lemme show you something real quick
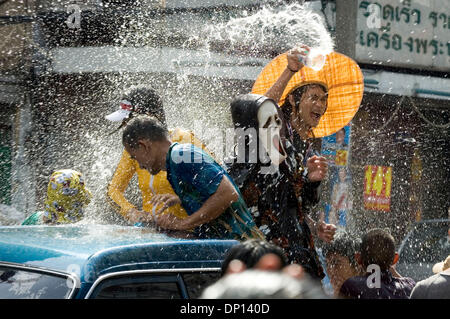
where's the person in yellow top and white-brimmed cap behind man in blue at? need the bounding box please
[106,87,208,223]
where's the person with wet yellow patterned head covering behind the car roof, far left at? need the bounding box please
[22,169,92,225]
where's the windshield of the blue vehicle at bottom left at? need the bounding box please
[0,267,73,299]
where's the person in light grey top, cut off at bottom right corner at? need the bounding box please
[410,255,450,299]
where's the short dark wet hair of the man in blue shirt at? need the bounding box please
[122,115,169,149]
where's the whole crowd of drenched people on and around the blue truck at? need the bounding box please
[18,48,450,298]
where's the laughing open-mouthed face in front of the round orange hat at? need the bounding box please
[289,85,328,128]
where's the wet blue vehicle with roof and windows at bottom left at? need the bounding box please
[0,225,238,299]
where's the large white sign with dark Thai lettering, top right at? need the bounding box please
[356,0,450,71]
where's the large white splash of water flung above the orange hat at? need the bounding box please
[205,3,334,57]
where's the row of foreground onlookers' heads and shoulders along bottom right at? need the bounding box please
[201,238,450,299]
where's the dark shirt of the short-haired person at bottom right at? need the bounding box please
[340,270,416,299]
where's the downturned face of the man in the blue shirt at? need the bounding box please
[125,140,166,175]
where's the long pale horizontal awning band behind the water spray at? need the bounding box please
[51,46,269,80]
